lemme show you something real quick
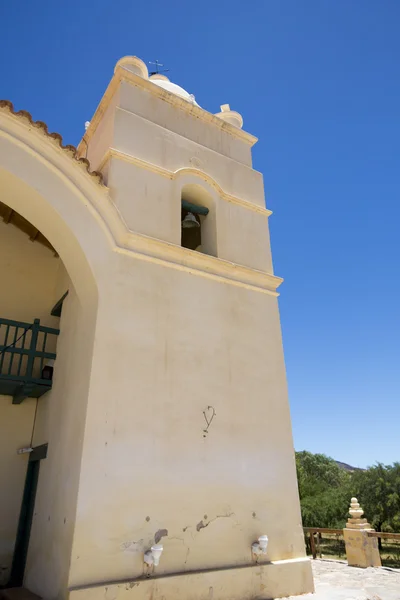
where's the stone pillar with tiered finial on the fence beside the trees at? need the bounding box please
[343,498,382,568]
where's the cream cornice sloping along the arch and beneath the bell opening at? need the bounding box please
[0,102,283,296]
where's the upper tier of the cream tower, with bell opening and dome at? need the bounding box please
[79,57,279,272]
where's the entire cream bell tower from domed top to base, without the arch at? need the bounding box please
[71,56,313,600]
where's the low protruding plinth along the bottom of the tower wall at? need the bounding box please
[69,558,314,600]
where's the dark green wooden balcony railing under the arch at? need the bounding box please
[0,318,60,404]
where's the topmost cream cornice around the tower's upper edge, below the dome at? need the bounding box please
[78,66,258,154]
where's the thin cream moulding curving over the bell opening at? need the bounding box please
[98,148,272,217]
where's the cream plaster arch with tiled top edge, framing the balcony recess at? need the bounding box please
[0,111,113,597]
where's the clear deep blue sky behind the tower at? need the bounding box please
[0,0,400,466]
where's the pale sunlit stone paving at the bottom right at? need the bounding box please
[282,560,400,600]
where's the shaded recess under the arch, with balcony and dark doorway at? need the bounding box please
[0,199,61,586]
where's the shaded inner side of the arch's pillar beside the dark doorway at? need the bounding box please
[25,283,96,600]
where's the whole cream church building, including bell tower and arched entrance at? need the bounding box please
[0,56,313,600]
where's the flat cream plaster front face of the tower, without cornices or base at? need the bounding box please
[69,67,304,586]
